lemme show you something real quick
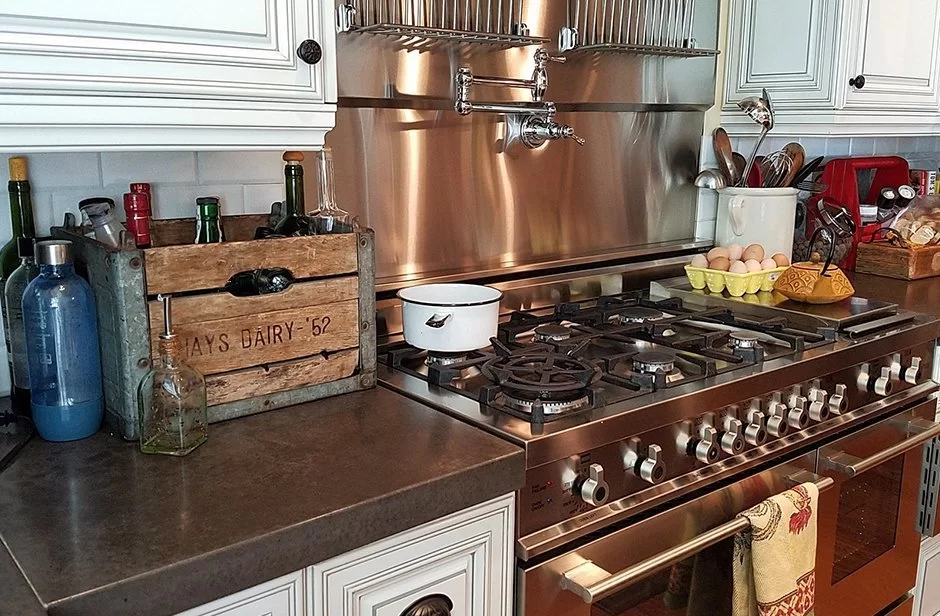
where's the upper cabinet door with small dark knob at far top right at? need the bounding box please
[843,0,940,111]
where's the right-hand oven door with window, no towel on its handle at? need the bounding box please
[816,398,940,616]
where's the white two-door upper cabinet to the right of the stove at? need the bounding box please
[722,0,940,136]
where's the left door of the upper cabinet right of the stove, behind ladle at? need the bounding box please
[724,0,838,113]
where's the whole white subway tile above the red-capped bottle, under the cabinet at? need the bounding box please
[101,152,196,185]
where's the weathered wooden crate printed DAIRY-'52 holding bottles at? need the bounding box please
[53,215,375,439]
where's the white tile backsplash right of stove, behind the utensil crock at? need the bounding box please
[695,133,940,239]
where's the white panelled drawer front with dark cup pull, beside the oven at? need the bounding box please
[307,495,514,616]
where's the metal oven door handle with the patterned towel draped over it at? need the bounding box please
[561,473,835,603]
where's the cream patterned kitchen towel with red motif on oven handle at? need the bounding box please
[733,483,819,616]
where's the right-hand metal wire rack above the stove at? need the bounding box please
[558,0,718,57]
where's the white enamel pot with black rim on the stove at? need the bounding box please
[398,284,503,353]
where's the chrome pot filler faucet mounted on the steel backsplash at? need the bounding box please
[454,48,585,149]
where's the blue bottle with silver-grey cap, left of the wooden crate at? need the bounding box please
[23,240,104,441]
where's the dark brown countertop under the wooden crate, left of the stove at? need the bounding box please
[0,388,525,616]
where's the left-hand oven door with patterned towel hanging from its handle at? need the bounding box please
[517,454,832,616]
